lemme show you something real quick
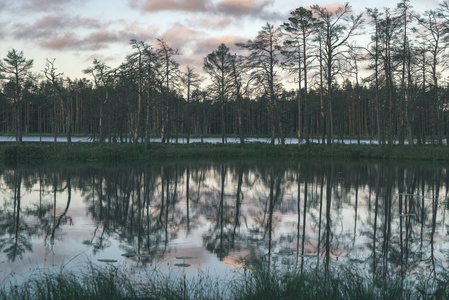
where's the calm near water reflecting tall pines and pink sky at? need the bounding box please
[0,161,449,283]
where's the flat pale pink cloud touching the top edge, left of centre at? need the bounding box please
[129,0,210,12]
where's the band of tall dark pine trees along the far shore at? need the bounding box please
[0,0,449,146]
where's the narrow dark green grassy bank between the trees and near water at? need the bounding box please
[0,143,449,163]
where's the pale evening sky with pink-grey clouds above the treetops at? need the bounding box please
[0,0,441,79]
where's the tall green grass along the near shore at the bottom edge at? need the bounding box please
[0,265,449,300]
